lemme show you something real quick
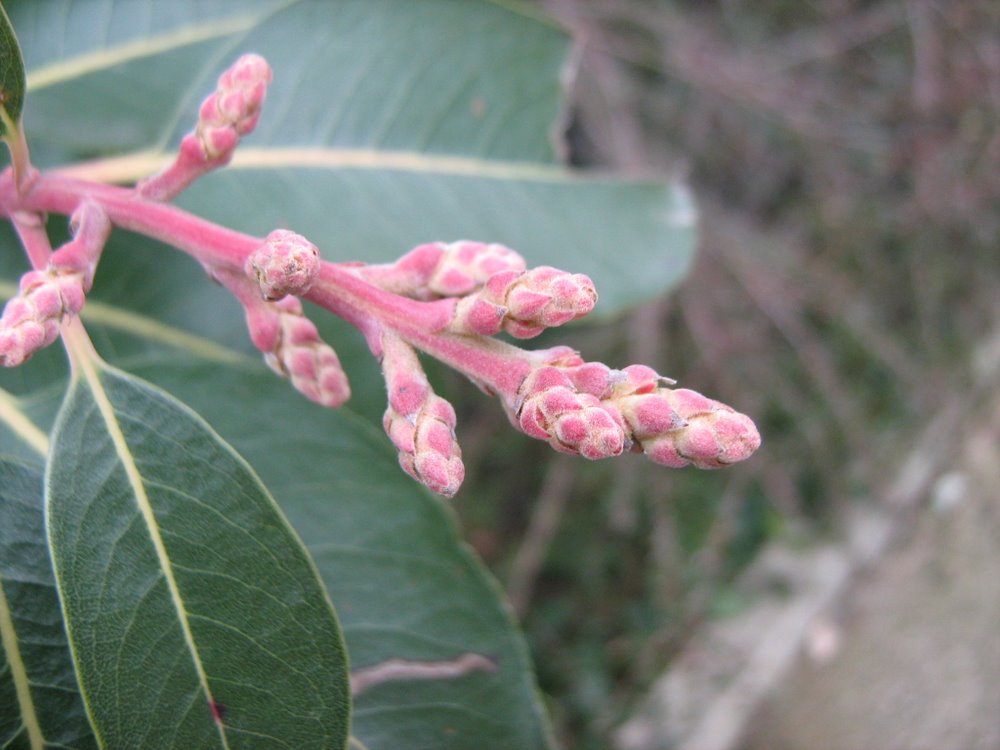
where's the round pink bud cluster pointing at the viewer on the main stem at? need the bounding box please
[246,229,320,300]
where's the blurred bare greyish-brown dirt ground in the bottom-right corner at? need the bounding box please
[744,390,1000,750]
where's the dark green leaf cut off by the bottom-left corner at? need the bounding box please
[0,459,97,750]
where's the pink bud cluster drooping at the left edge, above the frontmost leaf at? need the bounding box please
[0,202,111,367]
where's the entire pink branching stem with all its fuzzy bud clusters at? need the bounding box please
[0,55,760,496]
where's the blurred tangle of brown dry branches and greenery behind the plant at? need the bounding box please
[459,0,1000,748]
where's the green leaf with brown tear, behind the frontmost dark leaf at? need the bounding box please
[130,354,551,750]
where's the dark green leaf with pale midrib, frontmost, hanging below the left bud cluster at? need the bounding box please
[46,354,349,749]
